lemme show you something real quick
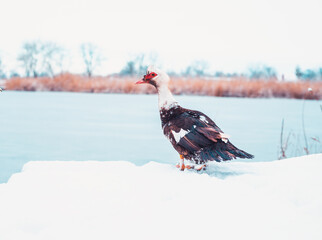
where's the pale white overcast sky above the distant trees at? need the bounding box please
[0,0,322,78]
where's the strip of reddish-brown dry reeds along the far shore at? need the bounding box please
[5,73,322,99]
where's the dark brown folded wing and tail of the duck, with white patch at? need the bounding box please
[163,110,253,163]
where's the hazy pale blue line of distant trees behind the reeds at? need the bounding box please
[0,41,322,81]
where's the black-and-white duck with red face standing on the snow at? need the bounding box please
[136,65,254,171]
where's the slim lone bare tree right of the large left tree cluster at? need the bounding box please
[80,43,103,77]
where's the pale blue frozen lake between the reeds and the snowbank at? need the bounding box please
[0,92,322,183]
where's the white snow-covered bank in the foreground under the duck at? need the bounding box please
[0,154,322,240]
